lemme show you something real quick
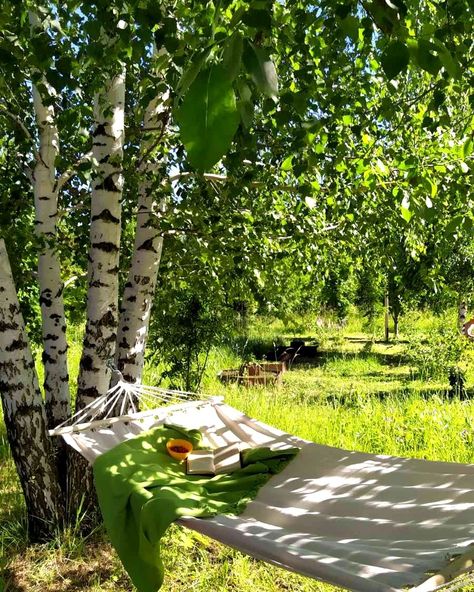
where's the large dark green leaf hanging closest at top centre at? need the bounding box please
[176,66,239,170]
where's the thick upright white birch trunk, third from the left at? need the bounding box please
[77,70,125,406]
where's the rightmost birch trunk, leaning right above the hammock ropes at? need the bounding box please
[116,96,167,383]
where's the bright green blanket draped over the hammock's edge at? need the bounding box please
[94,425,298,592]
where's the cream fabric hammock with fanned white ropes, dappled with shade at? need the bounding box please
[50,382,474,592]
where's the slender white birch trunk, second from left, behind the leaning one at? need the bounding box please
[29,11,70,427]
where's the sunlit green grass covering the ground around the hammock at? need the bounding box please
[0,314,474,592]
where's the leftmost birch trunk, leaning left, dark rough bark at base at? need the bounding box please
[0,239,62,540]
